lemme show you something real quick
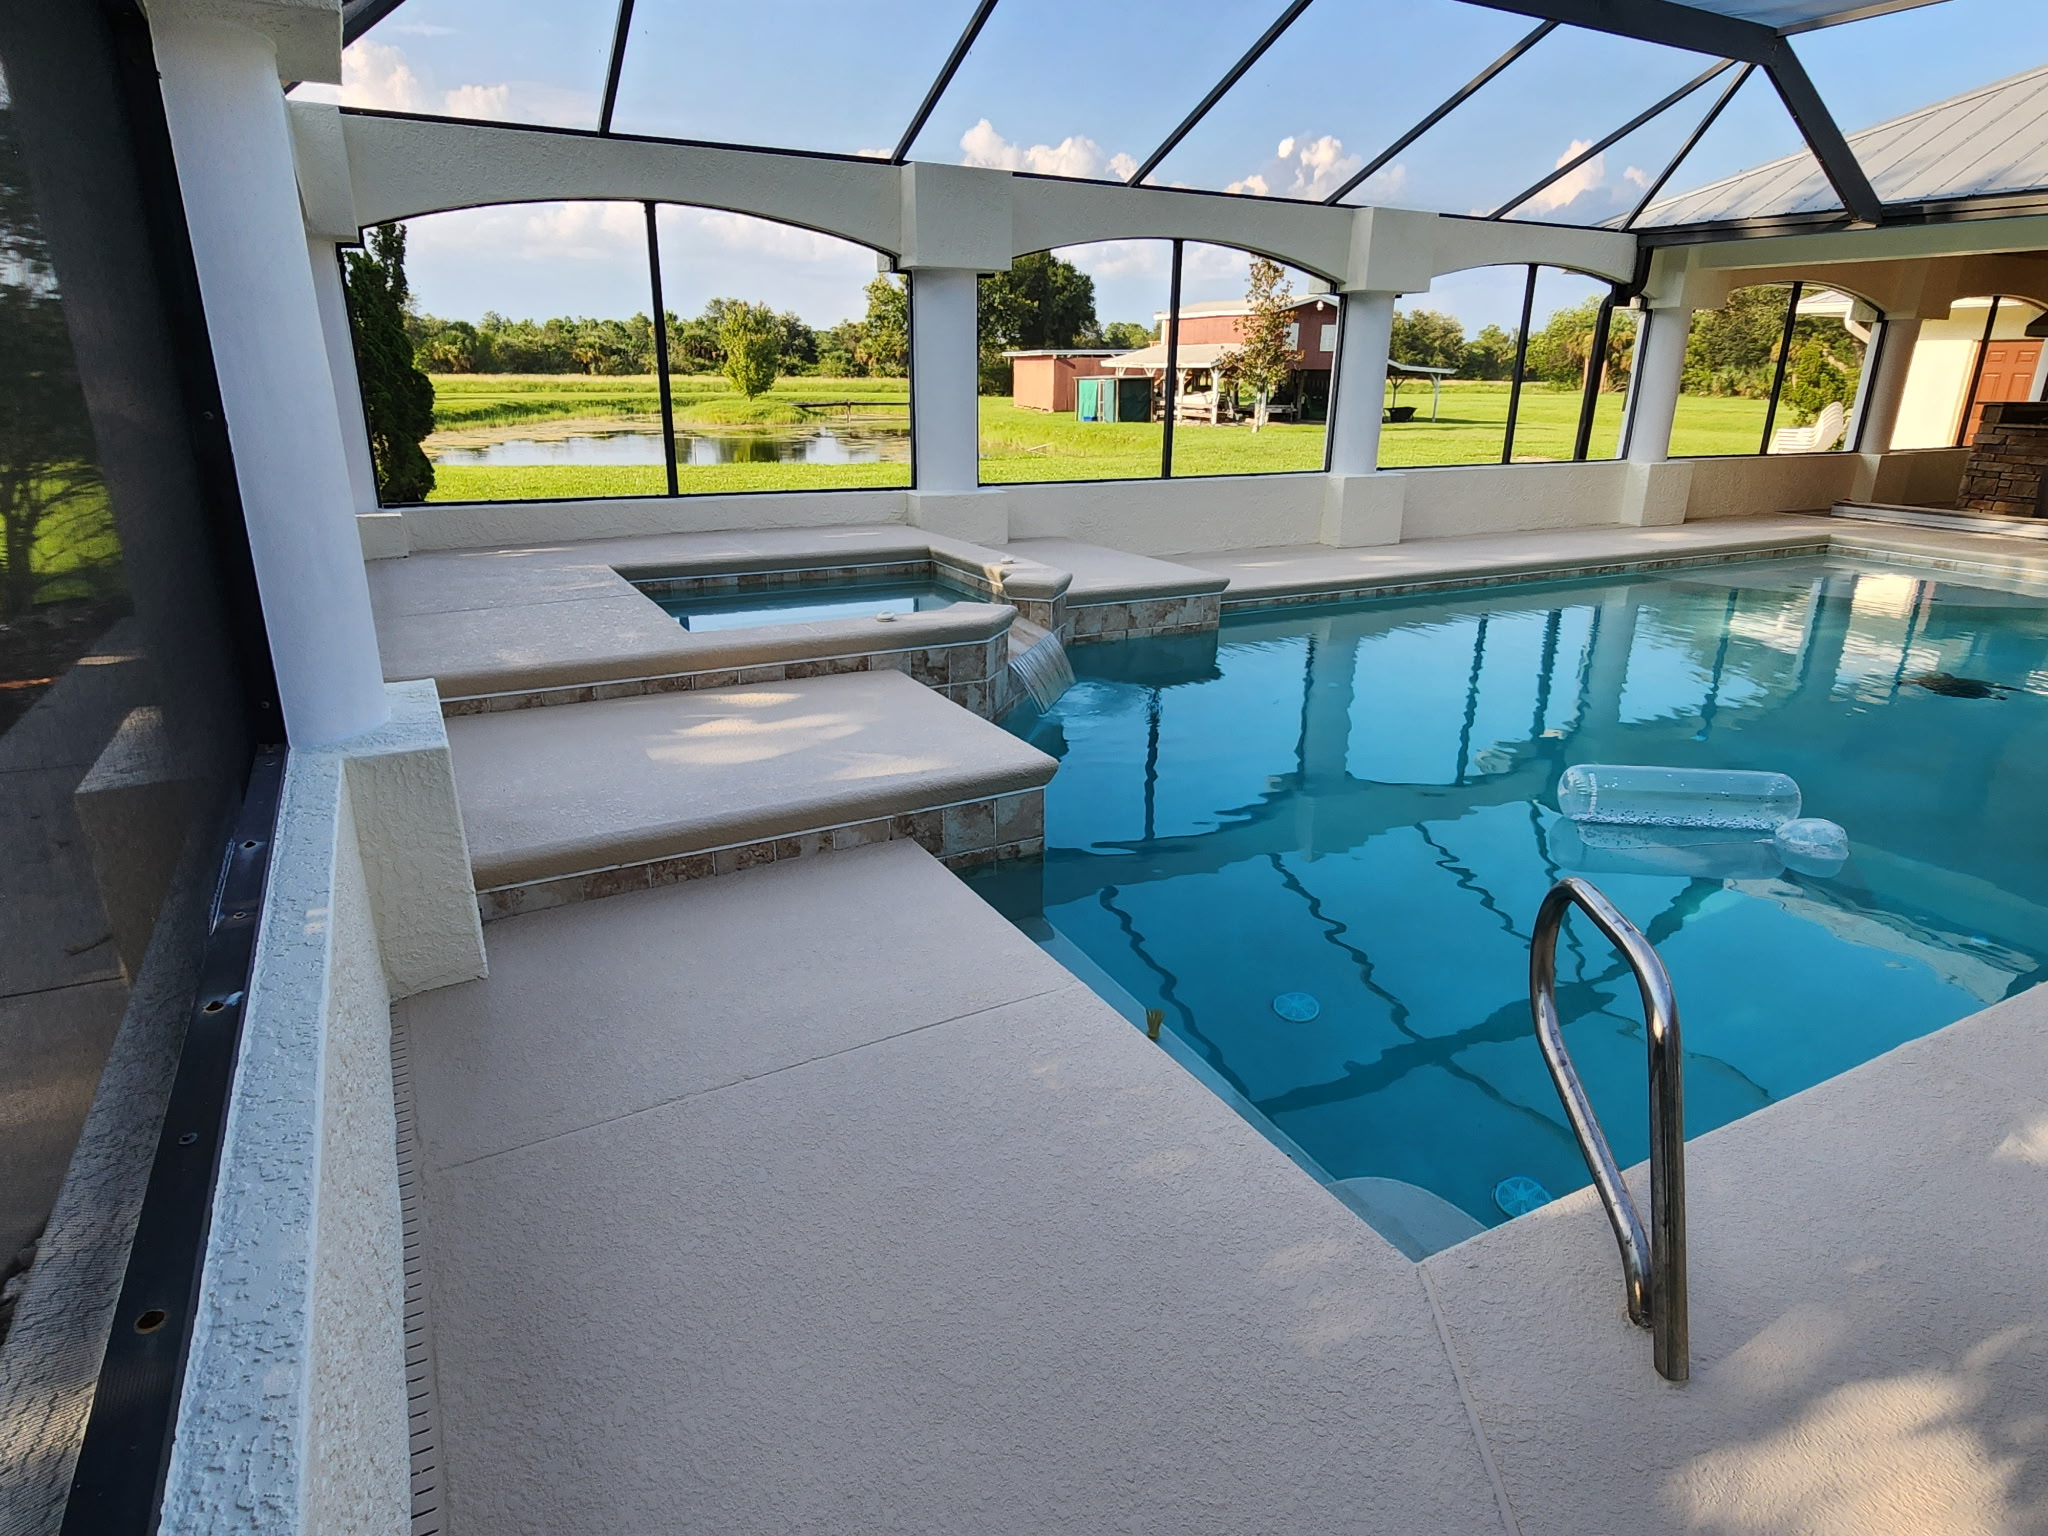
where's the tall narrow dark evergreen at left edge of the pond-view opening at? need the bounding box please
[346,223,434,502]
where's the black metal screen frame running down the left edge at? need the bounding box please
[0,0,287,1536]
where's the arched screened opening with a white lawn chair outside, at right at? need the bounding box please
[1671,283,1882,459]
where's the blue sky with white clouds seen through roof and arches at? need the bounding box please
[297,0,2048,332]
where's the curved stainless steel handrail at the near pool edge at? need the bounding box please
[1530,877,1692,1380]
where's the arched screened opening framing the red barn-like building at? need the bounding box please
[981,240,1341,483]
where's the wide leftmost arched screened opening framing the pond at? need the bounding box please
[346,203,911,504]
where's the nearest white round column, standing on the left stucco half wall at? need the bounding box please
[152,16,389,745]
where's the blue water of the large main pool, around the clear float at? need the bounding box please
[973,559,2048,1249]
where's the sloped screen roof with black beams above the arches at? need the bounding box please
[301,0,2048,227]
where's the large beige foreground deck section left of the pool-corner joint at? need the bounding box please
[397,844,1503,1536]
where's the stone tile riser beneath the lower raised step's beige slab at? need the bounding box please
[477,788,1044,922]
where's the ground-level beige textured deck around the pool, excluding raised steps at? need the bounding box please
[395,518,2048,1536]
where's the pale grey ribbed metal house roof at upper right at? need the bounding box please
[1634,66,2048,229]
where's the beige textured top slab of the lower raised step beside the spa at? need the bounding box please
[449,672,1057,889]
